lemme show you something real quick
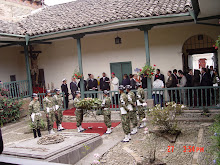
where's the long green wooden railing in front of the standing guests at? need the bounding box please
[84,86,220,110]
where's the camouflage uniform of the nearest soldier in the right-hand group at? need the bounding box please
[120,93,131,135]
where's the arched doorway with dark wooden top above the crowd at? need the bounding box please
[182,34,218,72]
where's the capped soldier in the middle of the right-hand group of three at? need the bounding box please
[125,85,138,135]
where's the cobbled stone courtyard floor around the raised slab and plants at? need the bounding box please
[2,113,213,165]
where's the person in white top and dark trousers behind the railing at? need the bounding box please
[152,77,164,107]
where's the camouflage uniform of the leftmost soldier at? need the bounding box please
[28,100,42,129]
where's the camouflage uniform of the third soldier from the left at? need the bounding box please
[53,94,63,127]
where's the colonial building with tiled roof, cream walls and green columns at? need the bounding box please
[0,0,220,105]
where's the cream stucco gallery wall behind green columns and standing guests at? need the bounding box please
[0,24,220,90]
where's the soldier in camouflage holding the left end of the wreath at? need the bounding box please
[73,91,85,132]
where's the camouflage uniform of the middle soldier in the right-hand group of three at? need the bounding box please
[128,91,138,128]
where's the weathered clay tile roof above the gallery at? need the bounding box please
[0,0,192,35]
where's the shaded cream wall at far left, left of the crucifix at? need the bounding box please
[0,46,26,82]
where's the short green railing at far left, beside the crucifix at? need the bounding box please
[0,80,30,99]
